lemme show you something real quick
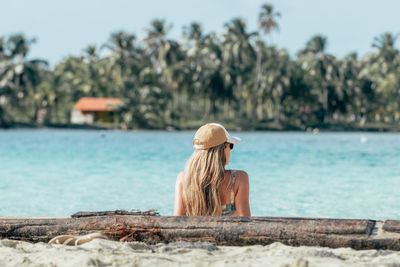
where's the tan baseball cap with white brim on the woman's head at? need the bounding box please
[193,123,242,149]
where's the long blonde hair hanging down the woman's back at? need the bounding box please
[182,143,226,216]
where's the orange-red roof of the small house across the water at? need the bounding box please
[73,97,121,111]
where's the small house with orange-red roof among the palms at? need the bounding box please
[71,97,121,124]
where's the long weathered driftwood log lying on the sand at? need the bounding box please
[0,211,400,250]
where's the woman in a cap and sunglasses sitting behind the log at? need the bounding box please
[174,123,250,216]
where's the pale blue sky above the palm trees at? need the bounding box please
[0,0,400,64]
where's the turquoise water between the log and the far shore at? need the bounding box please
[0,130,400,219]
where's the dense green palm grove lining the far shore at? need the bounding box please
[0,5,400,129]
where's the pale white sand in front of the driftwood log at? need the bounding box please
[0,239,400,267]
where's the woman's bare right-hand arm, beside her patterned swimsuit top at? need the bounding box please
[234,171,251,216]
